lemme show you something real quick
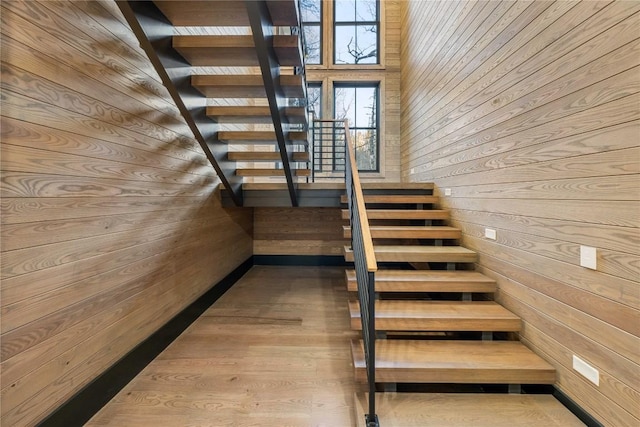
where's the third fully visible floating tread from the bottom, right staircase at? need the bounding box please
[345,270,496,293]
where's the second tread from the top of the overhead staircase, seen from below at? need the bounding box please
[173,34,302,67]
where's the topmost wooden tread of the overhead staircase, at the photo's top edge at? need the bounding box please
[154,0,299,27]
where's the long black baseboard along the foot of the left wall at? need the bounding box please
[38,257,253,427]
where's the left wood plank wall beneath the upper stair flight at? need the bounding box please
[0,1,253,426]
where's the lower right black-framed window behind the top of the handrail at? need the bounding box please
[333,83,379,172]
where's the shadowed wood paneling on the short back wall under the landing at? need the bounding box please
[253,208,347,255]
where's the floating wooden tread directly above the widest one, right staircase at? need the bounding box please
[349,300,521,332]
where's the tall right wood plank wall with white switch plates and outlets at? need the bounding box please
[401,1,640,427]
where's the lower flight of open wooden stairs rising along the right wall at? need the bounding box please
[343,184,555,392]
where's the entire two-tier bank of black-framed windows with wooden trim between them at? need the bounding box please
[299,0,386,174]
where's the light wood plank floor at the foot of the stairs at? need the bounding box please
[88,266,580,427]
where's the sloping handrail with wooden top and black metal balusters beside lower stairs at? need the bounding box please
[344,121,380,427]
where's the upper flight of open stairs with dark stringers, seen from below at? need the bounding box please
[117,0,310,206]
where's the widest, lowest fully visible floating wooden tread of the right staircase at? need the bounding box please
[351,340,555,384]
